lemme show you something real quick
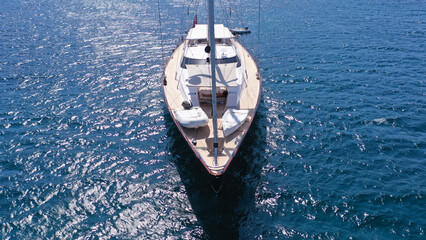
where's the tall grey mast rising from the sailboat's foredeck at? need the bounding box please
[208,0,219,165]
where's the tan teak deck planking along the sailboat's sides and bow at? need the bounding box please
[162,39,262,175]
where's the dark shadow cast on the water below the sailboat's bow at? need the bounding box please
[165,102,267,239]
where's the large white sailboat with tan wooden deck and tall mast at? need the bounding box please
[162,0,262,176]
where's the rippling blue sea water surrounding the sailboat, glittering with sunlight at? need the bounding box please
[0,0,426,239]
